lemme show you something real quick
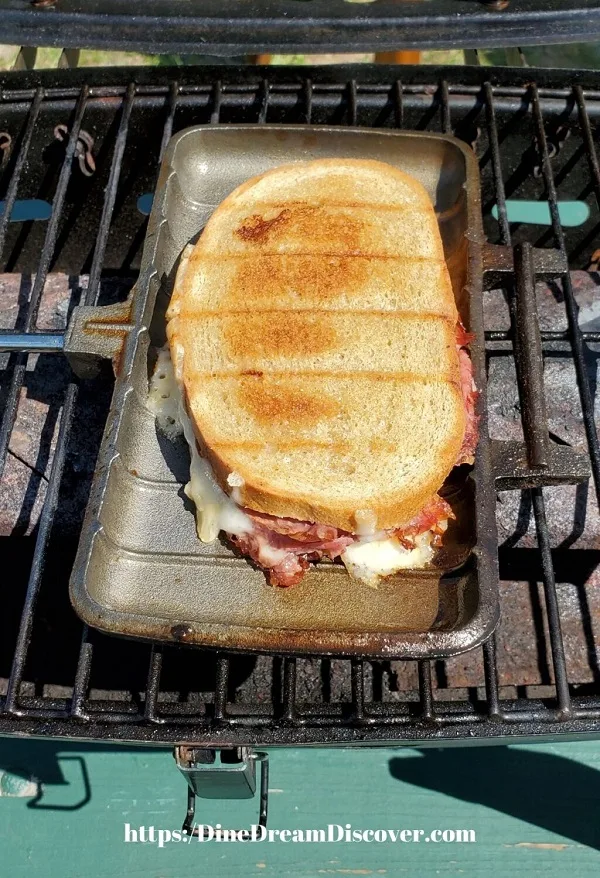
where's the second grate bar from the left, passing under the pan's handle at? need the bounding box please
[0,86,88,476]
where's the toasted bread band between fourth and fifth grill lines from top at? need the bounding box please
[193,372,461,446]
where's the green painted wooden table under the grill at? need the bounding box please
[0,738,600,878]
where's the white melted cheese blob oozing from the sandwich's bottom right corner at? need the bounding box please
[341,531,434,588]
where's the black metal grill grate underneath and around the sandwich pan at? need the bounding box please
[0,67,600,745]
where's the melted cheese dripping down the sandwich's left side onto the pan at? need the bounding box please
[148,347,252,543]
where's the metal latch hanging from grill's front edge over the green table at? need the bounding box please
[173,744,269,840]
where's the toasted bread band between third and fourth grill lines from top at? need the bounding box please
[180,310,458,382]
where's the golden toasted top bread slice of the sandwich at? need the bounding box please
[167,159,465,531]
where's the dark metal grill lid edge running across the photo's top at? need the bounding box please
[0,0,600,57]
